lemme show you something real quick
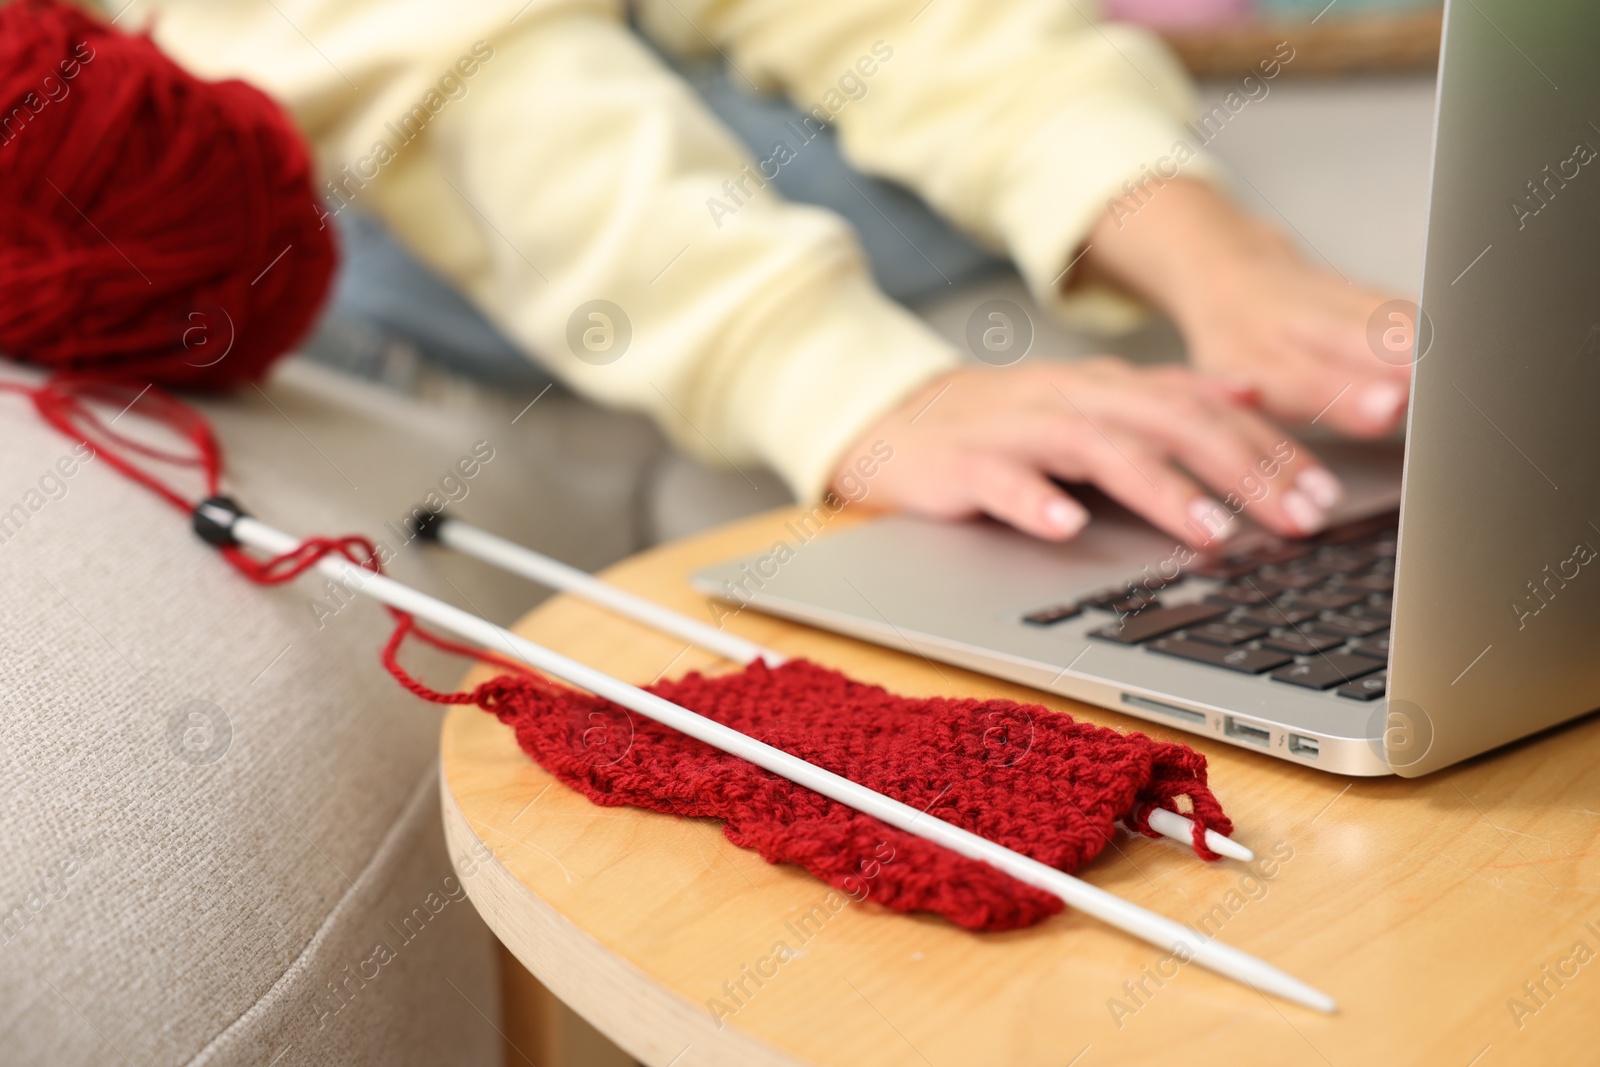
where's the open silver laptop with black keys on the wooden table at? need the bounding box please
[694,0,1600,776]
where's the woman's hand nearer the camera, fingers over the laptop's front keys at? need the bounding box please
[832,357,1342,547]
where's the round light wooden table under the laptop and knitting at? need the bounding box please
[442,510,1600,1067]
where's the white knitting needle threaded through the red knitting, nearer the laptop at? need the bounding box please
[414,510,1256,862]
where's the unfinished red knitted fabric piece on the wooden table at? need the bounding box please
[428,655,1232,929]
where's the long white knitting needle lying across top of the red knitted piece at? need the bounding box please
[216,502,1336,1013]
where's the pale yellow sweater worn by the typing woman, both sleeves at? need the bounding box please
[131,0,1190,499]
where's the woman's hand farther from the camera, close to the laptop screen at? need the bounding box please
[1085,179,1411,437]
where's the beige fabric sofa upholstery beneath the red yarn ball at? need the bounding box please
[0,356,659,1067]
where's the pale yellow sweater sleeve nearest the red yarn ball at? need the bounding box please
[134,0,957,499]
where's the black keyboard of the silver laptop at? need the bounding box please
[1022,514,1398,701]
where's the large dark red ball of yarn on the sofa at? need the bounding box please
[0,0,336,387]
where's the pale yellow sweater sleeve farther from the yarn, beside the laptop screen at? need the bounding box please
[640,0,1219,330]
